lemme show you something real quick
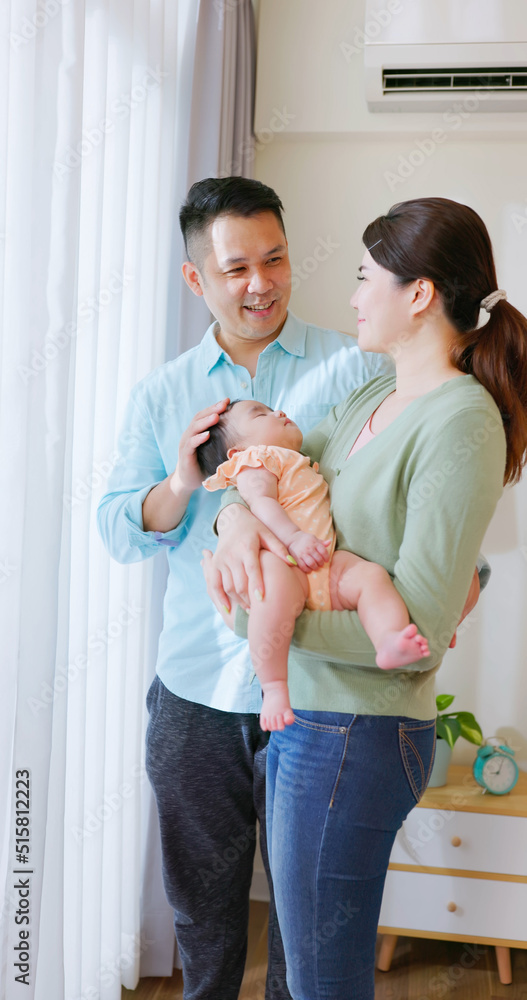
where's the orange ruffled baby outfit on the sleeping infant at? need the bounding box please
[203,445,335,611]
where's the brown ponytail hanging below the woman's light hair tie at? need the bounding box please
[450,300,527,485]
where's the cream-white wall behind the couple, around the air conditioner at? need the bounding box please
[255,0,527,767]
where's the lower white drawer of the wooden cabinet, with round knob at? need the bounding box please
[379,871,527,941]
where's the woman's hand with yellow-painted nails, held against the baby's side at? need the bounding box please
[202,503,292,617]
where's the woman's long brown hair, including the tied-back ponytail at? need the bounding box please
[362,198,527,483]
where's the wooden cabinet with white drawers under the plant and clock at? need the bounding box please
[378,766,527,983]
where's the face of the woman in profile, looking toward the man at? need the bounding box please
[351,250,415,354]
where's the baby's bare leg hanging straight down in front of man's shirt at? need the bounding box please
[251,552,308,730]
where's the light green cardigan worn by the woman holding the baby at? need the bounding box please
[231,375,506,719]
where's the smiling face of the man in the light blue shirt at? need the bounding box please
[200,212,291,343]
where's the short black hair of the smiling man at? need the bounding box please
[179,177,285,268]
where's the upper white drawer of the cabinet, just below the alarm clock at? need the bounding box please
[390,808,527,875]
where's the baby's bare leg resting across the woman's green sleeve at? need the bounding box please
[329,551,430,670]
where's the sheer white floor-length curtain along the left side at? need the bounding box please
[0,0,256,1000]
